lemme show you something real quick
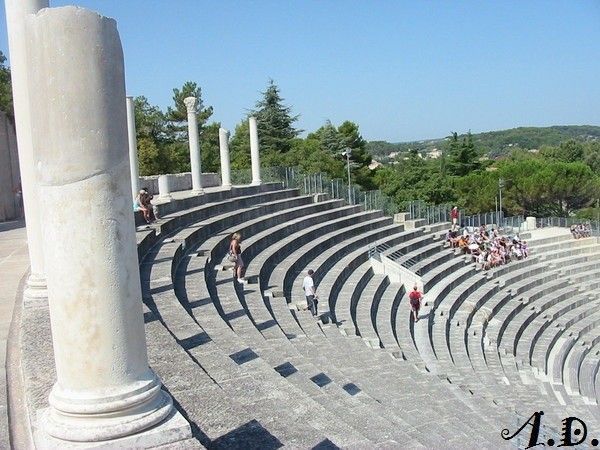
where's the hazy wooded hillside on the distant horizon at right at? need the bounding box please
[367,125,600,159]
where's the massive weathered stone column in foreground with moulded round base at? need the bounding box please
[27,6,189,448]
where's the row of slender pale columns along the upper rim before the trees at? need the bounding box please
[126,97,261,200]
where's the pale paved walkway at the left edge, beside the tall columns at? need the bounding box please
[0,222,29,448]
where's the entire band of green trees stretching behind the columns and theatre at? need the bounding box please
[0,52,600,218]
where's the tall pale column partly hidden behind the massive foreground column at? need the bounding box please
[4,0,48,303]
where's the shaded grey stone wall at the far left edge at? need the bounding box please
[0,111,21,222]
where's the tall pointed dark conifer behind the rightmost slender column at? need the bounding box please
[253,80,299,160]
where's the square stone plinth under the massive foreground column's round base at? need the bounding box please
[34,402,192,450]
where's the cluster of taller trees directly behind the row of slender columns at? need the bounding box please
[134,80,376,189]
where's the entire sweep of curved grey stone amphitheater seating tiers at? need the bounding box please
[18,184,600,449]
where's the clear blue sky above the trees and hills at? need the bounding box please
[0,0,600,142]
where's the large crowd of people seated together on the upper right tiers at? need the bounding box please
[446,225,529,270]
